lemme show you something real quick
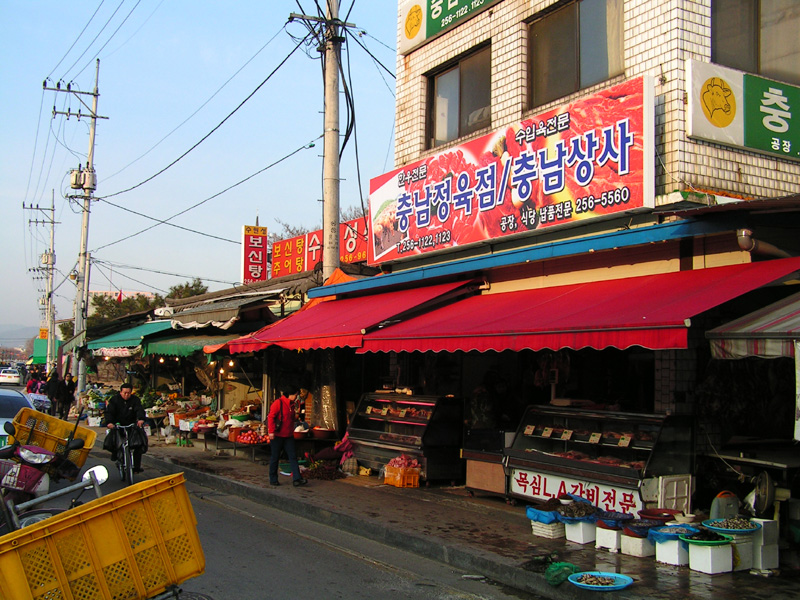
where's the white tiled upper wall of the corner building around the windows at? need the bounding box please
[395,0,800,202]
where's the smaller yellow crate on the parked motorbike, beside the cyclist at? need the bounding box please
[14,408,97,474]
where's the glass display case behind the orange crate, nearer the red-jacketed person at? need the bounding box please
[348,392,464,480]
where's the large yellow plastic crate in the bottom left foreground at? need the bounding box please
[0,473,205,600]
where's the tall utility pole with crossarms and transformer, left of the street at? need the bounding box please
[44,59,108,391]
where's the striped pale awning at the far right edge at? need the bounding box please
[706,292,800,359]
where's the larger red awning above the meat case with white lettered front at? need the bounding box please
[359,258,800,352]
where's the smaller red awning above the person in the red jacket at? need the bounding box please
[229,281,476,354]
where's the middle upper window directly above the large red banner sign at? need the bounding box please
[529,0,623,108]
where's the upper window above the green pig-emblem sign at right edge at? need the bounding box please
[711,0,800,84]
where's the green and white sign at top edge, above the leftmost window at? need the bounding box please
[397,0,500,55]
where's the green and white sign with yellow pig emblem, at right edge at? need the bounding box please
[686,60,800,160]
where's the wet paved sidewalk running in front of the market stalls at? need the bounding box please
[89,429,800,600]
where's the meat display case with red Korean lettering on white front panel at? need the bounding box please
[505,405,694,512]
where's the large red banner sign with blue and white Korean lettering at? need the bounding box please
[368,76,655,264]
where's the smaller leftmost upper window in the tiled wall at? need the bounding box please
[429,47,492,148]
